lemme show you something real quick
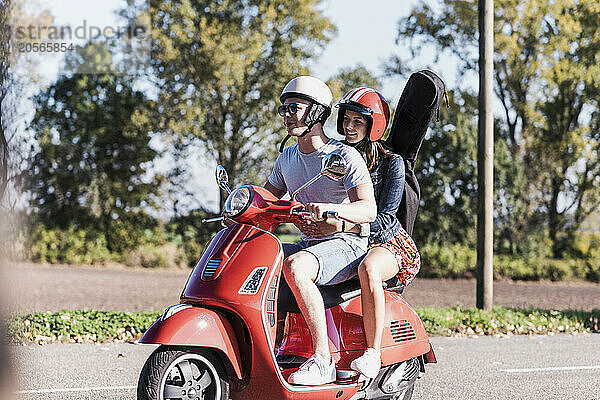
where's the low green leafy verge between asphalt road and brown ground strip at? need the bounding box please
[9,307,600,344]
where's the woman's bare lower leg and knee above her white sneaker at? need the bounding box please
[358,247,398,351]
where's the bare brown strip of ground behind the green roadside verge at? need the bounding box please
[2,263,600,313]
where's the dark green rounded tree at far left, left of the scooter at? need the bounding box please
[27,45,160,251]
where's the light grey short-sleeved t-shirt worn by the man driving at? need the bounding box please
[269,139,372,248]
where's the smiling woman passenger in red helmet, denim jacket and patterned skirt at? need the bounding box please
[300,88,421,378]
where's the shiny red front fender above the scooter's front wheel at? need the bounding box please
[139,307,242,379]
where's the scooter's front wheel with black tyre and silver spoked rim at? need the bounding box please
[137,346,229,400]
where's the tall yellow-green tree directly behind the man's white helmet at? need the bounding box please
[123,0,335,205]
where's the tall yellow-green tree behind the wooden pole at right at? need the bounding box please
[392,0,600,257]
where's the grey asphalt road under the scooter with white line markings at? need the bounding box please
[13,334,600,400]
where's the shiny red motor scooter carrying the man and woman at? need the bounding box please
[138,154,436,400]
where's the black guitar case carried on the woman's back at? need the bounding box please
[385,70,448,235]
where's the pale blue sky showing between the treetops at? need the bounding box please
[35,0,443,211]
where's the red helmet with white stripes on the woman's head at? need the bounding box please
[336,87,390,142]
